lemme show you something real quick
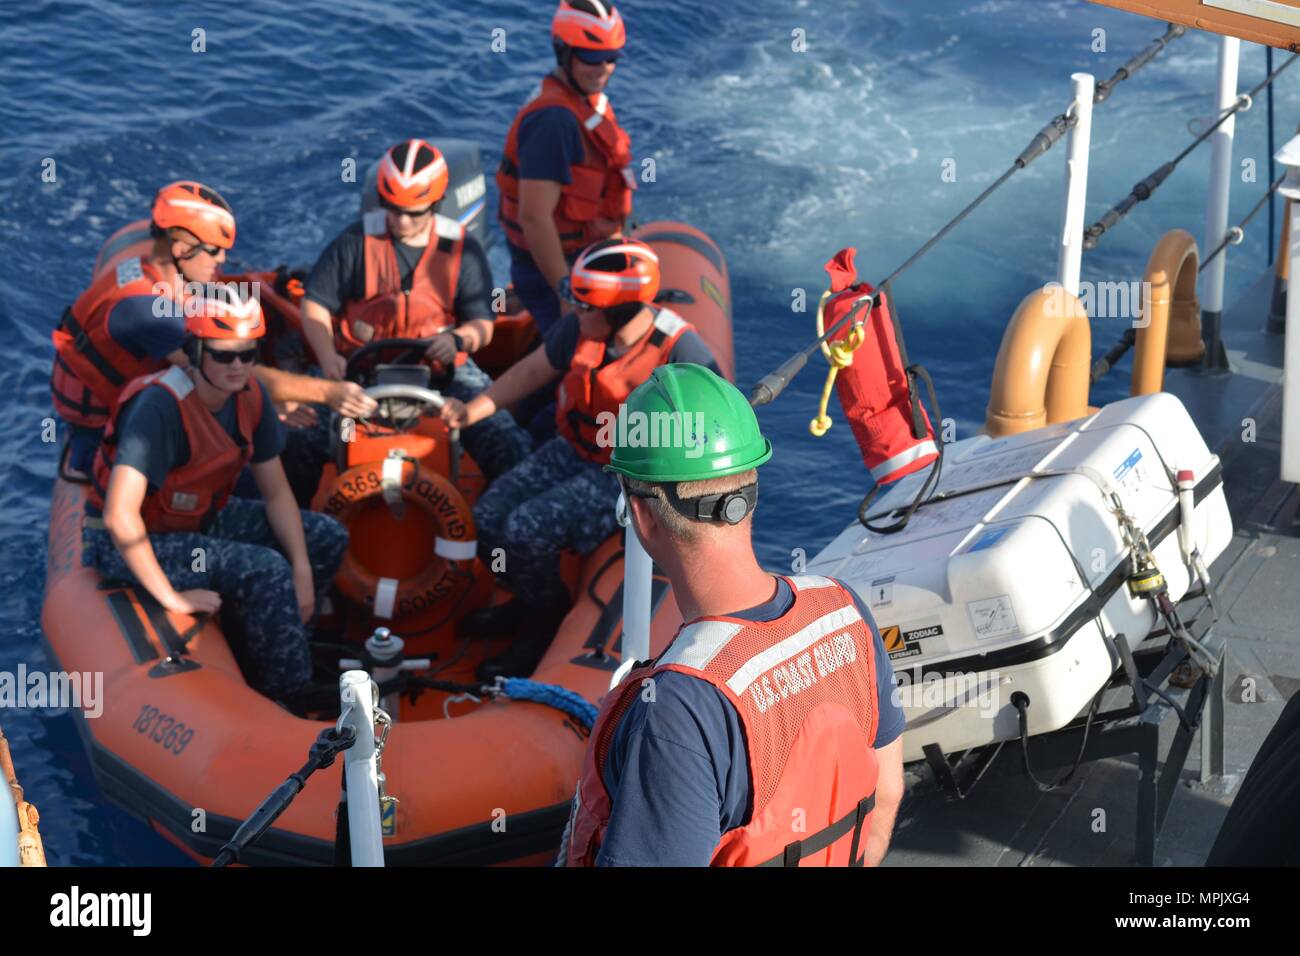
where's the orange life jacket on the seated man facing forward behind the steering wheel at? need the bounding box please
[337,209,465,364]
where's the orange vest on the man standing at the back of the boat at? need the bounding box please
[497,75,637,255]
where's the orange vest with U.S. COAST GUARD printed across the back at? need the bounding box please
[562,575,879,866]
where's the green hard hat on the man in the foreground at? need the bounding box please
[605,362,772,481]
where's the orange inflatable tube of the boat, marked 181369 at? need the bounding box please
[42,217,735,866]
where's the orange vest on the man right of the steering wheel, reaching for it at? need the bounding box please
[555,308,694,464]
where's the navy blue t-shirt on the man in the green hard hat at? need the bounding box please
[595,579,905,866]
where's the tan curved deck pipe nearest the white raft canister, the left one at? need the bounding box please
[984,284,1092,437]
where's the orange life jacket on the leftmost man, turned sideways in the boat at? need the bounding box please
[49,256,175,428]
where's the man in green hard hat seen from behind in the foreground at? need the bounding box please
[560,364,904,866]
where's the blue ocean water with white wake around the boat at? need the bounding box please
[0,0,1300,865]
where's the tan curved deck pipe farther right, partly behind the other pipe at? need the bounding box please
[1130,229,1205,395]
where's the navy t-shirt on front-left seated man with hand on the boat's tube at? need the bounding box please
[113,378,285,492]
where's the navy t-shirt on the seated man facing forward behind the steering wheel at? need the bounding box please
[307,222,497,323]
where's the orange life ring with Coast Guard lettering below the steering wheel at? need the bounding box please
[321,458,477,618]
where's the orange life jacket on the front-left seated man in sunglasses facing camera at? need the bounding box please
[88,365,263,535]
